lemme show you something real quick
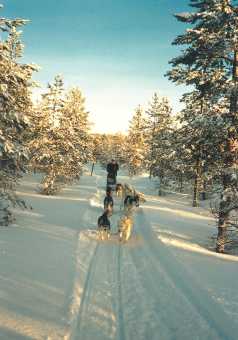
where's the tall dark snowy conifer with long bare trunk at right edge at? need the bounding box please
[167,0,238,252]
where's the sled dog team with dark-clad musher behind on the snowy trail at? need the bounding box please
[98,160,145,242]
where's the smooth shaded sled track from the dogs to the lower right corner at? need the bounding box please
[135,211,237,340]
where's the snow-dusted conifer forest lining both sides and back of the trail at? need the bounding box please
[0,0,238,253]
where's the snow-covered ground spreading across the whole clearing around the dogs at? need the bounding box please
[0,168,238,340]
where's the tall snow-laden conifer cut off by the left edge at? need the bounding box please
[0,7,36,225]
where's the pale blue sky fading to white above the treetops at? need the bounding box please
[0,0,188,132]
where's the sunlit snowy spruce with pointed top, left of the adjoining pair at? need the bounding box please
[30,76,67,195]
